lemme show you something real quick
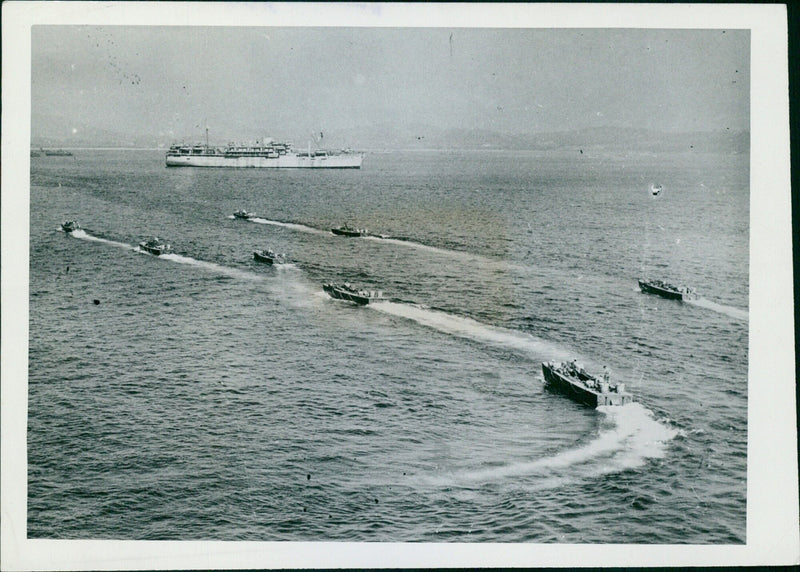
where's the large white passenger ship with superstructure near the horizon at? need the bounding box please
[166,134,364,169]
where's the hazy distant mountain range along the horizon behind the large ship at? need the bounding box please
[31,118,750,153]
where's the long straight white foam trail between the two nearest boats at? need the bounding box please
[368,302,574,360]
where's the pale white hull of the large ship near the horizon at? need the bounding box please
[166,154,363,169]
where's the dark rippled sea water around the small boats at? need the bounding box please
[28,146,749,543]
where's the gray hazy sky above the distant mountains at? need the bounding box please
[31,26,750,143]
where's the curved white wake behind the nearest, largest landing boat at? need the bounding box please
[426,403,679,488]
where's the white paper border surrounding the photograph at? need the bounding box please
[0,2,800,570]
